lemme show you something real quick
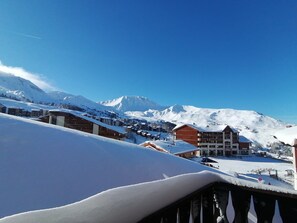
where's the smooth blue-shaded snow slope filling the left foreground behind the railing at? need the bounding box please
[0,114,214,217]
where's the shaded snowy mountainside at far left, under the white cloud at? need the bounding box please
[0,72,50,102]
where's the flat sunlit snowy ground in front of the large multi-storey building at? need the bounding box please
[191,156,294,189]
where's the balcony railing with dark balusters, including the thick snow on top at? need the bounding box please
[0,171,297,223]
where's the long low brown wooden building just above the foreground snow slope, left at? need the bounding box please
[41,111,125,140]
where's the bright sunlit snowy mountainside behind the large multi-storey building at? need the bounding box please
[125,105,286,147]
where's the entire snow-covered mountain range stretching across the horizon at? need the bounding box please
[0,72,286,147]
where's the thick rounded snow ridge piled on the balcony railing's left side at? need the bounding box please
[0,171,224,223]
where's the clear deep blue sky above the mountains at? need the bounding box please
[0,0,297,123]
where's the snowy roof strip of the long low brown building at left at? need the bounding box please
[50,109,126,134]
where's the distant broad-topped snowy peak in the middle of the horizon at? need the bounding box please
[99,96,164,112]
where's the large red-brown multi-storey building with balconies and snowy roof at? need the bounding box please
[173,124,249,156]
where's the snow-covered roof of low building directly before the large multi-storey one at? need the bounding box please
[142,140,199,155]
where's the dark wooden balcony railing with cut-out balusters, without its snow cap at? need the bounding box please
[140,182,297,223]
